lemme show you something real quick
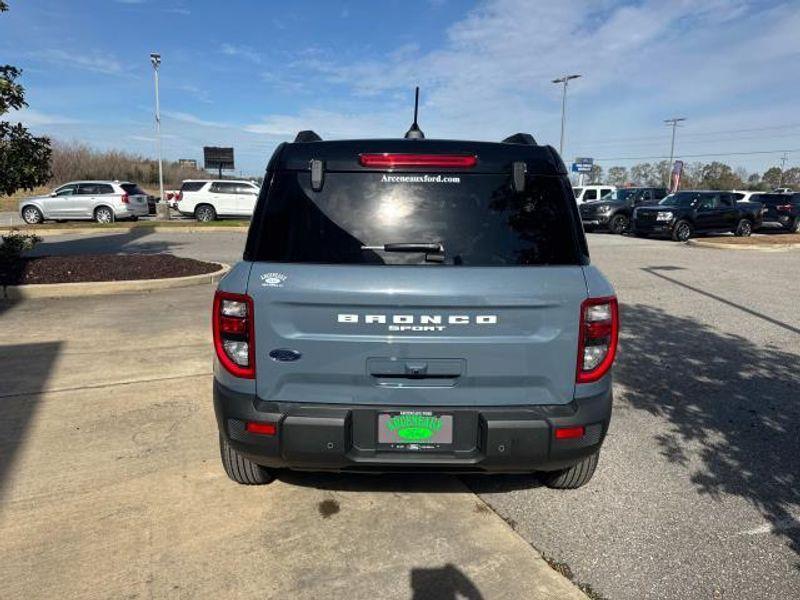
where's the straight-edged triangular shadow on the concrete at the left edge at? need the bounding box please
[0,340,61,500]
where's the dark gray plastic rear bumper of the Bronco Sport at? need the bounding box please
[214,380,612,473]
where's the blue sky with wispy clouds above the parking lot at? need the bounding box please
[0,0,800,174]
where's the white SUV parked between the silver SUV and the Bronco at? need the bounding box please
[177,179,261,222]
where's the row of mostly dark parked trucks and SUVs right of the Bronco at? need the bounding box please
[575,186,800,241]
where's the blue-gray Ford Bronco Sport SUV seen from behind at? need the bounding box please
[212,128,619,488]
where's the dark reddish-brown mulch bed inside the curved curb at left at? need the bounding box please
[0,254,220,285]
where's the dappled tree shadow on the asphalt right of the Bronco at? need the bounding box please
[615,305,800,564]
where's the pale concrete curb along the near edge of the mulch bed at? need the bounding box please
[0,263,231,300]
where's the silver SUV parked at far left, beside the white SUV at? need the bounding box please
[19,181,148,225]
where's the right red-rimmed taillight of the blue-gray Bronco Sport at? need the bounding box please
[576,296,619,383]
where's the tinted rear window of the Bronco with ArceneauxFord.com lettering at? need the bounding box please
[250,171,580,266]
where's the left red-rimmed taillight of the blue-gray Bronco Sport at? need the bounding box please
[212,292,256,379]
